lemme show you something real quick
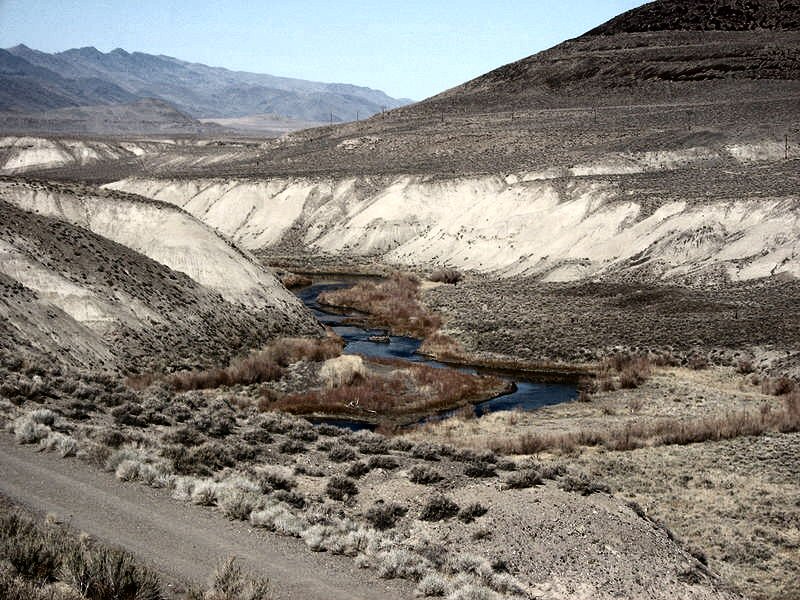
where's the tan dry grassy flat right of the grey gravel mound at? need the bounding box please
[407,367,800,600]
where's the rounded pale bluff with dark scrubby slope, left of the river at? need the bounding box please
[0,180,321,370]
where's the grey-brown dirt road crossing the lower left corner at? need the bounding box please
[0,434,412,600]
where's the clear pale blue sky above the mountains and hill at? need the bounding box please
[0,0,645,100]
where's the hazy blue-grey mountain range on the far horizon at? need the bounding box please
[0,45,411,122]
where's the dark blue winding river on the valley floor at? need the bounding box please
[295,277,578,430]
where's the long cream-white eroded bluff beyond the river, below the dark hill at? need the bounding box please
[107,142,800,282]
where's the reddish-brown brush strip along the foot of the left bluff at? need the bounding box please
[127,337,341,391]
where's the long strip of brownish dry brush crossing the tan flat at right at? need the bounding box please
[489,391,800,454]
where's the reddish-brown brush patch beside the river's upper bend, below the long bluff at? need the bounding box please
[318,273,441,338]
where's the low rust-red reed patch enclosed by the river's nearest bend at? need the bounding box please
[268,365,506,418]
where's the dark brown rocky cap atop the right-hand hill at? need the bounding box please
[586,0,800,36]
